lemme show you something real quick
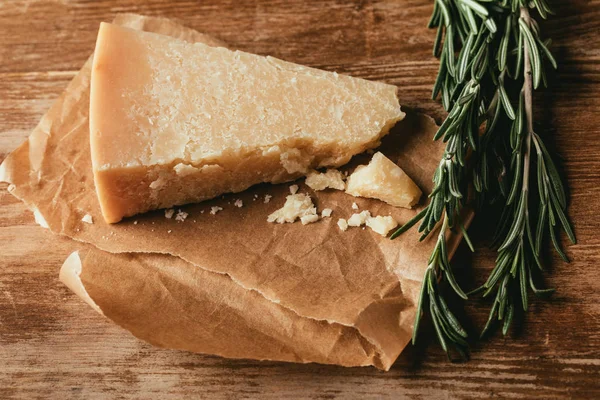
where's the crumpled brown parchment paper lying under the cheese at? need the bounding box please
[0,14,468,370]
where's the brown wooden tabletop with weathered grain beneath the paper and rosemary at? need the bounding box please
[0,0,600,399]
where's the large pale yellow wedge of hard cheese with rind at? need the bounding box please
[90,23,404,222]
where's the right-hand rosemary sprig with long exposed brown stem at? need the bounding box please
[478,5,576,335]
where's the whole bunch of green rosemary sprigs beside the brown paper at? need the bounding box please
[392,0,575,356]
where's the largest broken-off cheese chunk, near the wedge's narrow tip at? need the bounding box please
[346,152,422,208]
